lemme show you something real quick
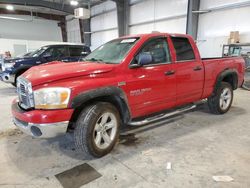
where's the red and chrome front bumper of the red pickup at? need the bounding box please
[12,100,73,138]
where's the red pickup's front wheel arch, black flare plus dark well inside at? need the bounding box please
[70,86,130,128]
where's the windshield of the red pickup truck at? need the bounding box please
[85,37,139,64]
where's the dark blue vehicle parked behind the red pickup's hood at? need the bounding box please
[0,44,91,85]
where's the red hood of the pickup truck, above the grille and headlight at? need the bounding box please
[23,62,116,86]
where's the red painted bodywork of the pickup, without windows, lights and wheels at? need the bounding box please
[12,33,244,123]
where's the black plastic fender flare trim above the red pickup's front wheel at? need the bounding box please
[70,86,131,123]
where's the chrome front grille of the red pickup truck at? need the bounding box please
[17,77,34,109]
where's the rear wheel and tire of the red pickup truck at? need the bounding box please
[208,82,233,114]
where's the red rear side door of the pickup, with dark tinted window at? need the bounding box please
[171,37,204,105]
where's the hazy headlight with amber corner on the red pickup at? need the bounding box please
[34,87,70,109]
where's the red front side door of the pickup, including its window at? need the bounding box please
[126,37,176,117]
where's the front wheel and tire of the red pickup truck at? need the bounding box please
[74,102,121,158]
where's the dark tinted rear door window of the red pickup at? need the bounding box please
[171,37,195,61]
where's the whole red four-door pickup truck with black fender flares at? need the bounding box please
[12,33,245,157]
